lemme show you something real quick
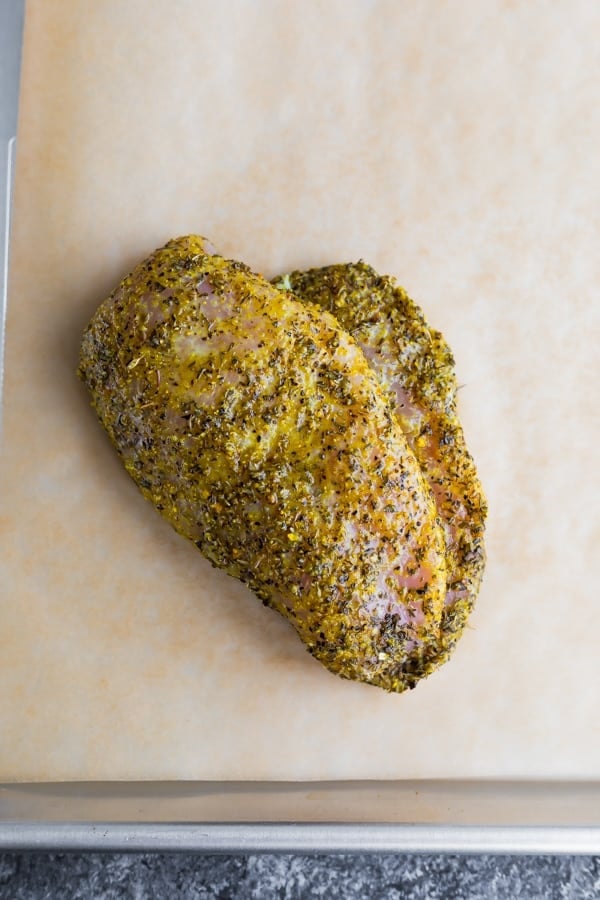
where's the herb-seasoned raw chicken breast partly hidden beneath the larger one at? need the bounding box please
[273,262,487,677]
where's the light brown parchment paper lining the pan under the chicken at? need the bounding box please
[0,0,600,780]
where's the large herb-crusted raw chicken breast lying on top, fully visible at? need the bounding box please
[79,236,447,691]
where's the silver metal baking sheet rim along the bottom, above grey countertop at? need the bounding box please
[0,780,600,854]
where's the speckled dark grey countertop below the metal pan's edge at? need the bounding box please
[0,853,600,900]
